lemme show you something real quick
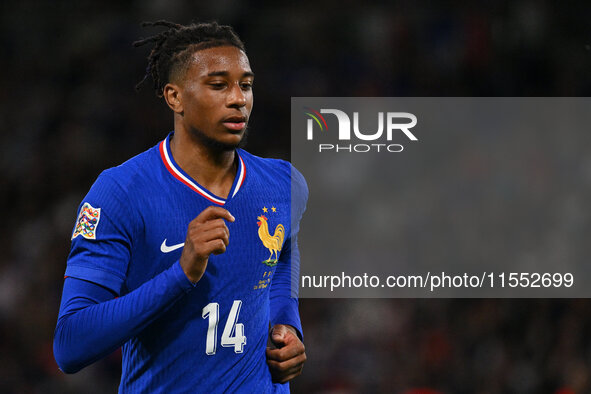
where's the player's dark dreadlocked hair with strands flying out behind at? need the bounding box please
[133,20,245,97]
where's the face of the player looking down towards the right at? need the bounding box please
[179,46,254,149]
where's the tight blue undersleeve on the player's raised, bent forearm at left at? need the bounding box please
[53,261,194,373]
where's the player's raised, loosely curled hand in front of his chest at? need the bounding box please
[180,206,235,283]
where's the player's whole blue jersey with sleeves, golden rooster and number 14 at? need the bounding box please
[54,133,308,393]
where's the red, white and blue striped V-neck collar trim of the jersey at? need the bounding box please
[159,135,246,205]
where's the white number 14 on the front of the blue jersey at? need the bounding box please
[201,300,246,356]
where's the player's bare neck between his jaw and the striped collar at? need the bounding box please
[170,130,238,198]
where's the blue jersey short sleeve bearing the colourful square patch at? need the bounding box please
[65,172,136,294]
